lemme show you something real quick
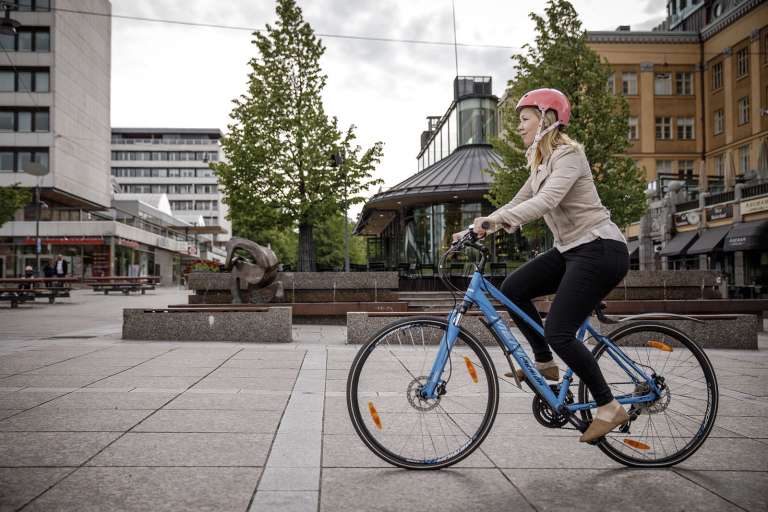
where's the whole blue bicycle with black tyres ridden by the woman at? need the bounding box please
[347,230,718,469]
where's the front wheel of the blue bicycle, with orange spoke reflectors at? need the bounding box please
[347,317,499,469]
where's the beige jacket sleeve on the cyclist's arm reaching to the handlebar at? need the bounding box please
[489,151,584,233]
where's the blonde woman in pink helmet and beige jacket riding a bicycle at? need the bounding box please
[454,89,629,442]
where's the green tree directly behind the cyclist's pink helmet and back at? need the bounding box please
[488,0,647,242]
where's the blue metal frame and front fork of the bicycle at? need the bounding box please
[422,271,661,417]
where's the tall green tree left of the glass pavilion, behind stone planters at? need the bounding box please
[212,0,381,271]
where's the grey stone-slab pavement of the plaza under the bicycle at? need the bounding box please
[0,288,768,511]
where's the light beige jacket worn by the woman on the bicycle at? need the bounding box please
[488,145,611,245]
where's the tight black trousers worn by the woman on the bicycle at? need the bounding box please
[501,238,629,405]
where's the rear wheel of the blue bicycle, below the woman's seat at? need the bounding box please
[579,322,719,467]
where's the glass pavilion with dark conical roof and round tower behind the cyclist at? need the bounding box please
[355,76,512,268]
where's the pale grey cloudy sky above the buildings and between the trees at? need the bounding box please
[112,0,666,216]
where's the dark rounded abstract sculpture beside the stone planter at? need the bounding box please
[225,238,283,304]
